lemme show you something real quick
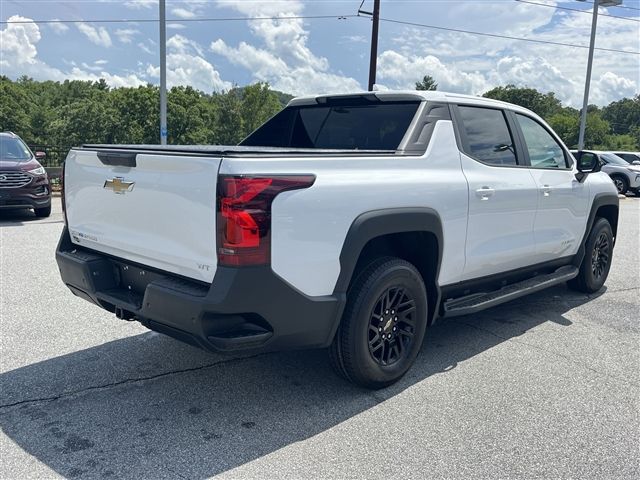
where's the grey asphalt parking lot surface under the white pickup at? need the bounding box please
[0,196,640,479]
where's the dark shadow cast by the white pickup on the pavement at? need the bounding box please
[0,287,593,479]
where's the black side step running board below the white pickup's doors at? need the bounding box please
[443,265,578,317]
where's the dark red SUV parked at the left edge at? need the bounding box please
[0,132,51,217]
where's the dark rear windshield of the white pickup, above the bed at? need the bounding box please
[240,102,420,150]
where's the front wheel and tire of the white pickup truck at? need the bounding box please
[567,218,613,293]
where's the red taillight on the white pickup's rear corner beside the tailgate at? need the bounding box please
[217,175,315,266]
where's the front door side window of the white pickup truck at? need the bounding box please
[516,114,567,168]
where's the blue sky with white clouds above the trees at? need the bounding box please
[0,0,640,106]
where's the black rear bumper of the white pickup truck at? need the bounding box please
[56,228,344,351]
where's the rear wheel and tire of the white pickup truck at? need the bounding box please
[329,257,428,389]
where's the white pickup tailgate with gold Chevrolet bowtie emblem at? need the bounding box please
[64,150,221,283]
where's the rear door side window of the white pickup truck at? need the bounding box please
[458,106,517,166]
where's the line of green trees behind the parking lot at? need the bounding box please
[0,76,640,166]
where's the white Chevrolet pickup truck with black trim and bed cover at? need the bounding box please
[57,91,618,388]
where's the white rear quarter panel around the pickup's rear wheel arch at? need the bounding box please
[220,121,468,296]
